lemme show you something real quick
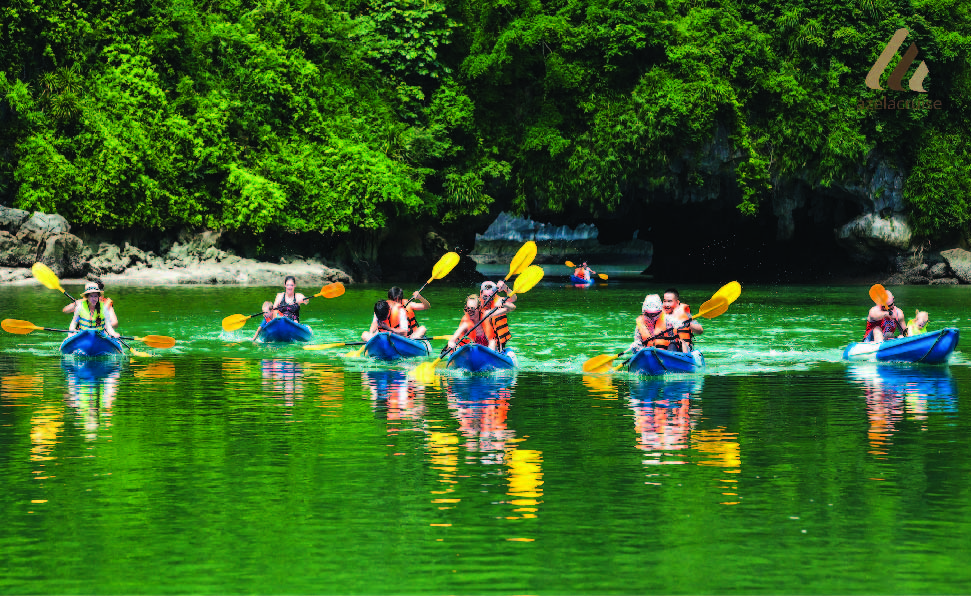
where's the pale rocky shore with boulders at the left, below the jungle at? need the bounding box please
[0,207,354,286]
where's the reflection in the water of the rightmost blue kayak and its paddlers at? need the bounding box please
[847,362,957,459]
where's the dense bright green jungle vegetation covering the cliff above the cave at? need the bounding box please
[0,0,971,243]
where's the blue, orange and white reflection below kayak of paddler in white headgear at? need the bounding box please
[630,377,704,465]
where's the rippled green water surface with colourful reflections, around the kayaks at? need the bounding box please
[0,280,971,594]
